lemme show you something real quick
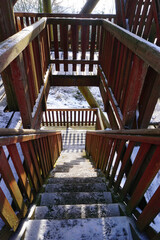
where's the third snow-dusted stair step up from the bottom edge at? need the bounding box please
[40,192,112,206]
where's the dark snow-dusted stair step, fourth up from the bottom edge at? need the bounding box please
[45,183,107,192]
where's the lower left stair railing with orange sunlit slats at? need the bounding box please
[0,129,62,235]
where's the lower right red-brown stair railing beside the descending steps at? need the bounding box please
[86,130,160,236]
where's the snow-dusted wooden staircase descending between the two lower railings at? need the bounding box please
[12,130,147,240]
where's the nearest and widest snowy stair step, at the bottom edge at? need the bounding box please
[24,217,132,240]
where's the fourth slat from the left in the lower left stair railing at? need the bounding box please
[21,142,39,192]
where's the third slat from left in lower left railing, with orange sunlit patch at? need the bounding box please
[7,144,33,202]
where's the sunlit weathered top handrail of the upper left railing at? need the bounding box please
[0,18,47,72]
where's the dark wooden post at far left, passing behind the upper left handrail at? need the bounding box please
[0,0,18,111]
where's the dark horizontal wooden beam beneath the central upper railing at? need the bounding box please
[50,75,99,86]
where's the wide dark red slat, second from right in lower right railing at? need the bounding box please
[127,146,160,213]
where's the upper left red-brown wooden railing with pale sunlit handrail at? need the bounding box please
[0,18,51,128]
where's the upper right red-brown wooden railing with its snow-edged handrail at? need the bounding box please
[99,20,160,129]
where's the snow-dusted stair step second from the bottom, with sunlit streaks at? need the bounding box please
[34,203,120,220]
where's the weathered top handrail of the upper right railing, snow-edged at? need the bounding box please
[102,20,160,73]
